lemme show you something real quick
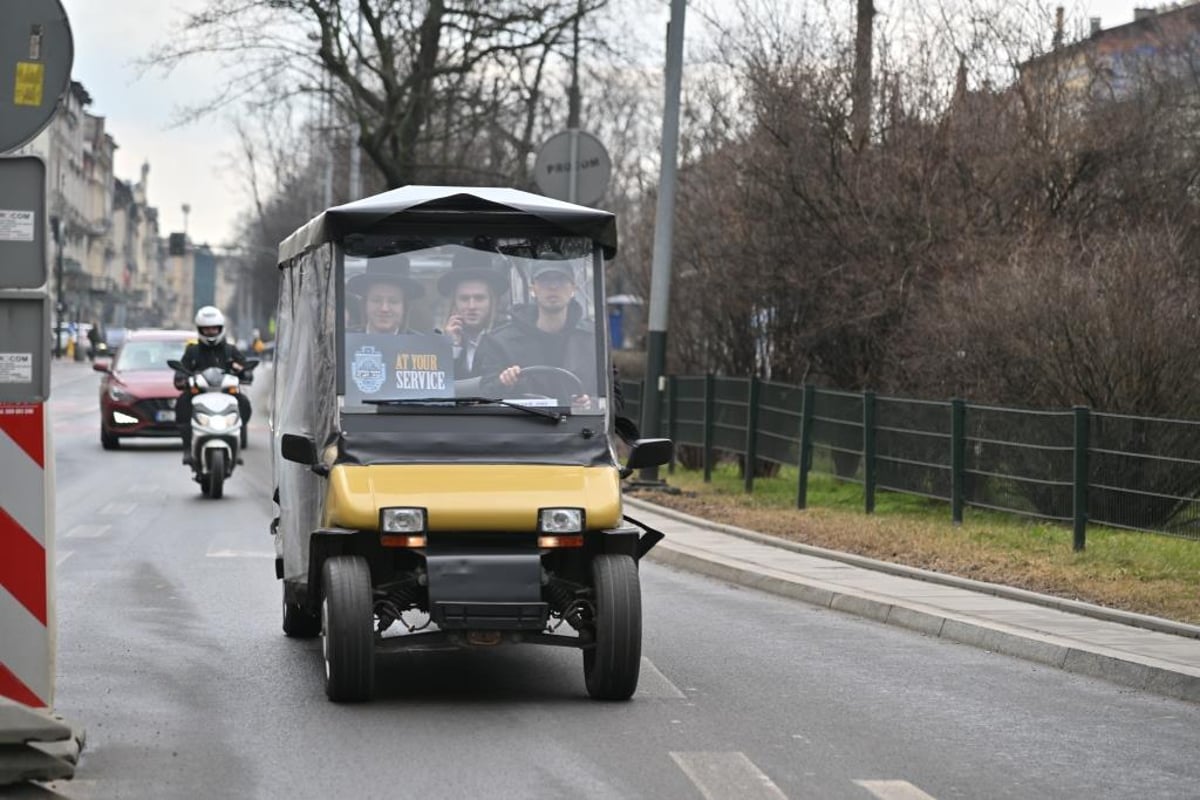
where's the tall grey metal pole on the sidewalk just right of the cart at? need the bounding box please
[641,0,688,481]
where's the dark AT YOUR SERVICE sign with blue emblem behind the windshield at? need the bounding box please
[344,333,455,405]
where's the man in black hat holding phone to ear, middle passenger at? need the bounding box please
[438,252,508,380]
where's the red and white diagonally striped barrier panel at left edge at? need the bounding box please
[0,403,54,708]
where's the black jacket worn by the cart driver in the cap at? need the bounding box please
[474,302,596,397]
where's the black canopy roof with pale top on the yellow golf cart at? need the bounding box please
[278,186,617,264]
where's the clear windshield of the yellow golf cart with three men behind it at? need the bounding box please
[342,236,607,414]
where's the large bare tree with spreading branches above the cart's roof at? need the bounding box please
[150,0,608,187]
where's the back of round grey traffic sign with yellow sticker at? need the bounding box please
[0,0,74,152]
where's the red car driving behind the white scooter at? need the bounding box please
[92,330,196,450]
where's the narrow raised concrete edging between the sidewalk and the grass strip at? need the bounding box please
[624,494,1200,639]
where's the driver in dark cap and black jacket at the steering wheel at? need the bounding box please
[475,260,596,405]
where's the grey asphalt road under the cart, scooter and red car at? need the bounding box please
[29,365,1200,800]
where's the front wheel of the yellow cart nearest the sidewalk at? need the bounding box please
[583,554,642,700]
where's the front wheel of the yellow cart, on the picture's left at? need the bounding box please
[320,555,374,703]
